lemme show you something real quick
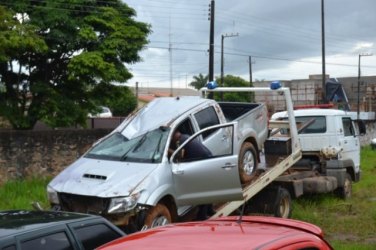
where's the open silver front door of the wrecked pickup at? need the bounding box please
[172,123,242,205]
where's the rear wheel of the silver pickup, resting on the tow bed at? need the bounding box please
[238,142,258,184]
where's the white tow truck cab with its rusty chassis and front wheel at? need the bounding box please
[265,109,365,199]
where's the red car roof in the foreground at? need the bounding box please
[98,216,333,250]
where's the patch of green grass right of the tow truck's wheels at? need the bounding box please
[292,147,376,249]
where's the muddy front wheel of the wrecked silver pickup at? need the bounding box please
[144,203,172,229]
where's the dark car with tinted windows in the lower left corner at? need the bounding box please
[0,210,125,250]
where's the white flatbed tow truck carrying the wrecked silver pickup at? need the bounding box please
[202,84,366,218]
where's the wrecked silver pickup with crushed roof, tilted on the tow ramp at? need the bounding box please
[47,94,268,232]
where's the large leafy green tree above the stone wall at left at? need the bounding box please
[0,0,150,129]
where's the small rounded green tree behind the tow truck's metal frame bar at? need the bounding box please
[214,75,254,102]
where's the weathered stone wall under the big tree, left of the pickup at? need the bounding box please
[0,129,112,185]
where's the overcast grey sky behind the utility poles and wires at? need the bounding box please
[124,0,376,88]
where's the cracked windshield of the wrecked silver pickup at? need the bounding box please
[85,127,170,163]
